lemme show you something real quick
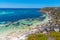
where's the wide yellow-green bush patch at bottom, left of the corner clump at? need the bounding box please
[27,33,48,40]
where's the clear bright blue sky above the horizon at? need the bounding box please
[0,0,60,8]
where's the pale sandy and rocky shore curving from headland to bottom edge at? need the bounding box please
[4,9,60,40]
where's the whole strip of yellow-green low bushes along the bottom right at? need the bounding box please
[27,31,60,40]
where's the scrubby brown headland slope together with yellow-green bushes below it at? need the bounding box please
[28,7,60,40]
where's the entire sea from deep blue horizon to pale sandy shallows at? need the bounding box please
[0,8,48,39]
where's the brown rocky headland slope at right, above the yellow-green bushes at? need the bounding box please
[41,7,60,32]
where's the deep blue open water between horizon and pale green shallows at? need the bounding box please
[0,8,43,22]
